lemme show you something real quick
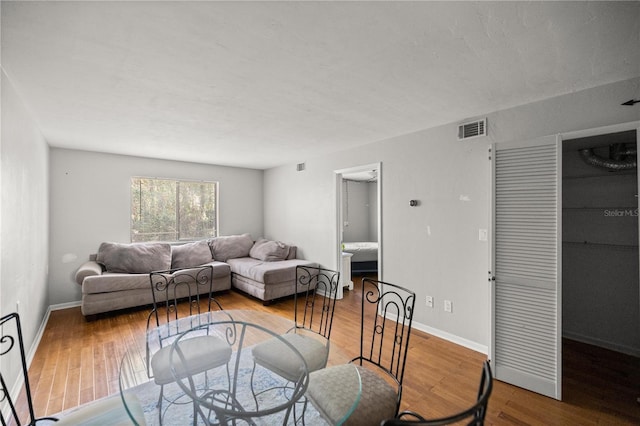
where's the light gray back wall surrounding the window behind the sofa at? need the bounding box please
[49,149,263,305]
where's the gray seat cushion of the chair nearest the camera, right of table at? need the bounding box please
[307,364,398,426]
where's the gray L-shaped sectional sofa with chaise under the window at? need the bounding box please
[75,234,318,317]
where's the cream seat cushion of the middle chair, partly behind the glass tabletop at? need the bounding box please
[252,333,329,382]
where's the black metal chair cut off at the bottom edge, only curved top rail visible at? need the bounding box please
[381,361,493,426]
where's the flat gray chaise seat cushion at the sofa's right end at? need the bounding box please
[227,257,317,285]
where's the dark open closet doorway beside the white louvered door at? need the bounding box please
[562,129,640,406]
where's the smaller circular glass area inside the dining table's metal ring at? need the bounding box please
[169,319,309,424]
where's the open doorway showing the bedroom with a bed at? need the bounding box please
[335,163,382,289]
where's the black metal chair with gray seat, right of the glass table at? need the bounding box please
[307,278,415,425]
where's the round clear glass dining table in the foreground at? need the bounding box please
[119,310,362,426]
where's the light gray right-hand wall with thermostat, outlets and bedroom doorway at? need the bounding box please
[265,78,640,350]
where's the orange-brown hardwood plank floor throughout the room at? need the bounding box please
[15,280,640,425]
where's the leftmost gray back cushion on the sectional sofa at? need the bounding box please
[96,243,171,274]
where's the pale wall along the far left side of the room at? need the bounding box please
[0,71,49,370]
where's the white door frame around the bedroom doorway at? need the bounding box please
[334,162,383,281]
